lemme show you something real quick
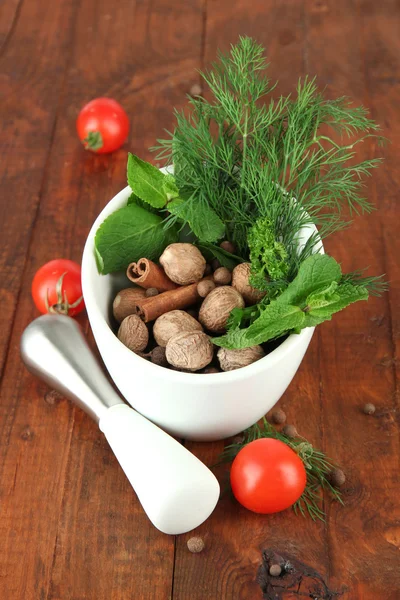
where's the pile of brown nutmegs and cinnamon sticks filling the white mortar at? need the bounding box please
[112,241,272,374]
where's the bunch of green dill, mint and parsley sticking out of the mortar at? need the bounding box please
[96,38,385,348]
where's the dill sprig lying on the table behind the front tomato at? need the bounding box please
[219,417,343,521]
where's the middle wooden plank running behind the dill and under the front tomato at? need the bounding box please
[173,0,329,600]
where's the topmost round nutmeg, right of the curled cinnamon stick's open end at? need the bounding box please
[160,243,206,285]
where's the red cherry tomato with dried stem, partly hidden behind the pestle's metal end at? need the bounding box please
[32,258,85,317]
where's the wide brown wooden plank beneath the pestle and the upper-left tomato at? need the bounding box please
[0,0,202,600]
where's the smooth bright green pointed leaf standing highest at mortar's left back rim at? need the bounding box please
[127,154,168,208]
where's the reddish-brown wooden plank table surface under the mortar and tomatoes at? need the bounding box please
[0,0,400,600]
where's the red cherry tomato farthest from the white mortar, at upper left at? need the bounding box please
[76,98,129,154]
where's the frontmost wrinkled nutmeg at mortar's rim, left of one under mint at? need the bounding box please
[166,331,214,371]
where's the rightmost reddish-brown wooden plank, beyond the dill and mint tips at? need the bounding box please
[307,2,400,600]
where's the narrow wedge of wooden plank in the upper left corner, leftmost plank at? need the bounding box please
[0,0,78,374]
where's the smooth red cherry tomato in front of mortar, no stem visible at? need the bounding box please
[231,438,307,514]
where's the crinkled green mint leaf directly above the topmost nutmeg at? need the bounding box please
[168,198,225,242]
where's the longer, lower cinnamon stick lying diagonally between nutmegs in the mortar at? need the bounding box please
[135,276,211,323]
